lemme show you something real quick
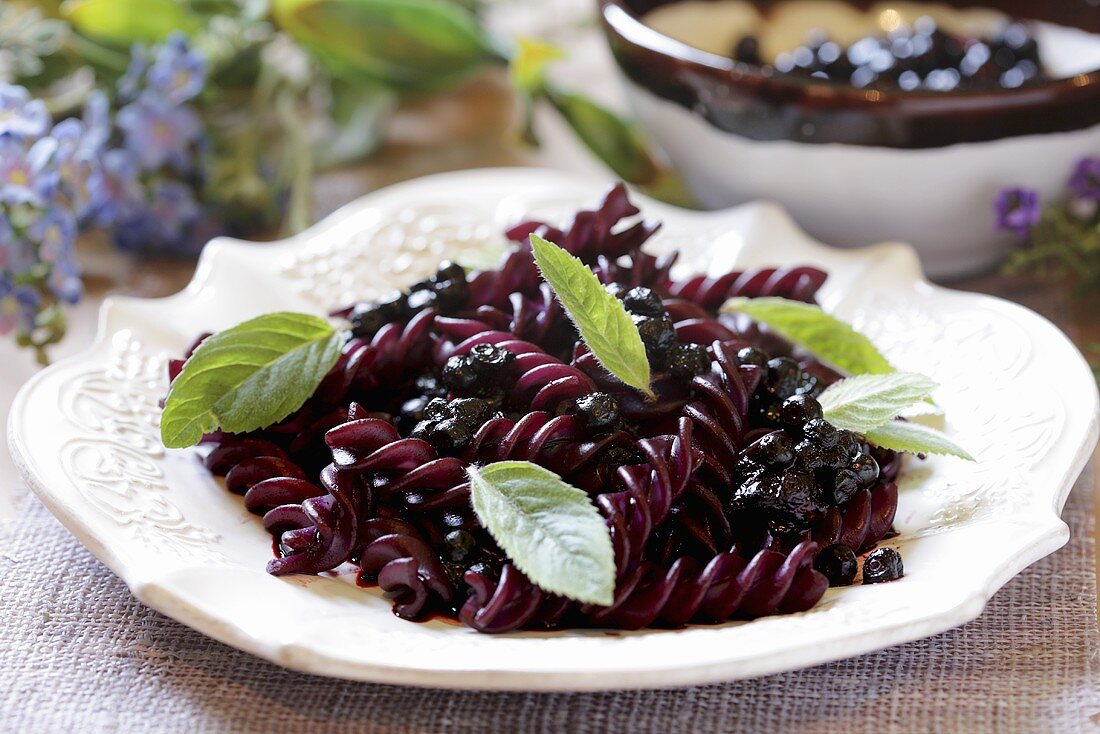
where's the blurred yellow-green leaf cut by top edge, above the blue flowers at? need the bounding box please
[61,0,199,46]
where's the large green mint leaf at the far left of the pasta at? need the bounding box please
[161,313,341,449]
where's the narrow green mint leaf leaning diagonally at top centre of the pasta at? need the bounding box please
[531,234,653,397]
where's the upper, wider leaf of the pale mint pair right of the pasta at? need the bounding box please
[817,372,936,432]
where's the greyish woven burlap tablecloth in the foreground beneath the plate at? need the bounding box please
[0,470,1100,734]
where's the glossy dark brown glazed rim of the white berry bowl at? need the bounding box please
[601,0,1100,149]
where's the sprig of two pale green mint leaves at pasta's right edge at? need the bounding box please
[817,372,975,461]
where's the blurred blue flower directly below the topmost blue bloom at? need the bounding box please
[118,92,202,171]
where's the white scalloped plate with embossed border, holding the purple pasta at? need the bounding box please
[9,169,1098,690]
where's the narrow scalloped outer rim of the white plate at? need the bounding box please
[8,168,1100,691]
